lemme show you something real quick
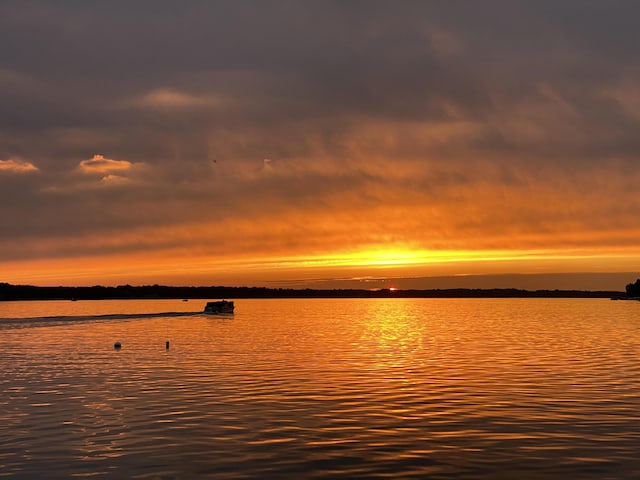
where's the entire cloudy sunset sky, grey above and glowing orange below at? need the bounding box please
[0,0,640,289]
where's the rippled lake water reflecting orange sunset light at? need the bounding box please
[0,299,640,479]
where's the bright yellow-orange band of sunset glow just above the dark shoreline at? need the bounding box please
[5,244,640,286]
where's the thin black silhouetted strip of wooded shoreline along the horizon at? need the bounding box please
[0,283,626,301]
